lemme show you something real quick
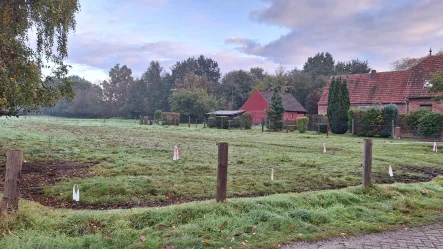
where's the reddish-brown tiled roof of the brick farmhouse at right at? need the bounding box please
[318,55,443,105]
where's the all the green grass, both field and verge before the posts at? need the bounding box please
[0,117,443,249]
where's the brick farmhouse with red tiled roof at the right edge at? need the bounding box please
[318,54,443,114]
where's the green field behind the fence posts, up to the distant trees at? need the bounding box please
[0,117,442,205]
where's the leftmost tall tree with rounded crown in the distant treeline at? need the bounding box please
[102,64,134,116]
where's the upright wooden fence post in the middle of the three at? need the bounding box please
[215,143,228,202]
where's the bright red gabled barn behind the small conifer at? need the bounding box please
[241,90,307,124]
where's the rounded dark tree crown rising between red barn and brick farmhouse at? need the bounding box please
[303,52,335,78]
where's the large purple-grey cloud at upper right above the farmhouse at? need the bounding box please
[243,0,443,69]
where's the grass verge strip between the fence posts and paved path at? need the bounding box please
[0,178,443,249]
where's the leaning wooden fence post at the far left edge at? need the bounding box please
[0,150,23,214]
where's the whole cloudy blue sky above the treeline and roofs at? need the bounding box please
[67,0,443,83]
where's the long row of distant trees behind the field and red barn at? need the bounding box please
[41,53,370,118]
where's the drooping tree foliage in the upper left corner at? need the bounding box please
[0,0,80,116]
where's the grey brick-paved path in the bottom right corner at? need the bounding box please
[282,222,443,249]
